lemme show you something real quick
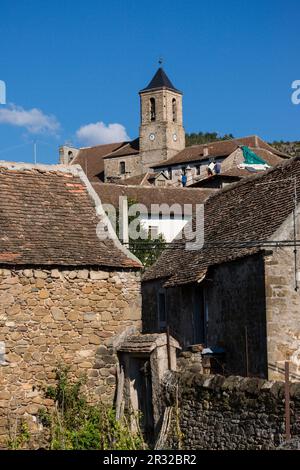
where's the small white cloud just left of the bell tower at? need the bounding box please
[76,122,130,146]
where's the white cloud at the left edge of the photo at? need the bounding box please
[0,104,60,134]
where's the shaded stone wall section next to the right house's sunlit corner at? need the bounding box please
[205,254,268,378]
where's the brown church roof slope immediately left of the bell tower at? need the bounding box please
[72,142,127,178]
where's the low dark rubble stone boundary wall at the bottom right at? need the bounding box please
[161,372,300,450]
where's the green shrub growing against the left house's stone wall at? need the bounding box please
[39,367,145,450]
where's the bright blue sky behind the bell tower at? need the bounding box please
[0,0,300,163]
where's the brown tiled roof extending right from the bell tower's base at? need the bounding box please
[153,135,289,168]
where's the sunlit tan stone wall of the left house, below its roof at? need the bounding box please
[0,269,141,446]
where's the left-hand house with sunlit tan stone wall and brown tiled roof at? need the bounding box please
[0,162,141,446]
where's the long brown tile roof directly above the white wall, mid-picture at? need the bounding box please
[93,183,214,214]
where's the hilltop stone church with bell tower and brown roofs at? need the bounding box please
[60,67,288,187]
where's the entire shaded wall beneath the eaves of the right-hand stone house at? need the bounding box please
[142,255,268,378]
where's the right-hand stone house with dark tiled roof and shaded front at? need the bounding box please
[142,157,300,380]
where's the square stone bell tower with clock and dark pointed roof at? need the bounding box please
[139,67,185,171]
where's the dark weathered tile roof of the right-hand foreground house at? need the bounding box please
[144,157,300,286]
